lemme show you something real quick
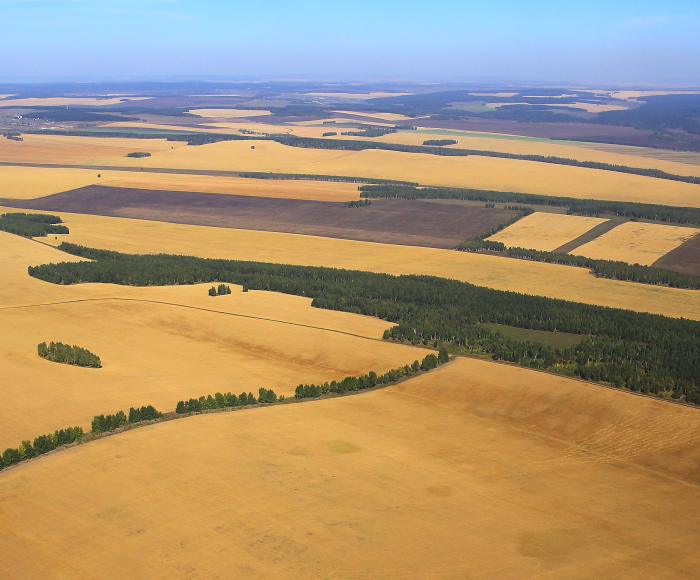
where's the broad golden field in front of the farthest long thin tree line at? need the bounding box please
[100,141,700,207]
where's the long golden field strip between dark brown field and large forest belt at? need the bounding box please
[17,208,700,320]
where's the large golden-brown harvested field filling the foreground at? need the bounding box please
[0,360,700,580]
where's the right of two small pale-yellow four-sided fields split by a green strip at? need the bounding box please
[571,222,700,266]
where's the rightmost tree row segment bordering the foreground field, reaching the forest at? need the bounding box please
[294,346,450,399]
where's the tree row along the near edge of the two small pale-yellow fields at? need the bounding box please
[457,240,700,290]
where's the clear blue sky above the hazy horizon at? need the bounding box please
[0,0,700,87]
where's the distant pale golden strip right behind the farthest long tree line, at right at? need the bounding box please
[376,129,700,176]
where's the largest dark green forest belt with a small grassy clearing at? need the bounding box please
[29,243,700,403]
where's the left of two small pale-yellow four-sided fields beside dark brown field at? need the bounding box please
[489,212,606,252]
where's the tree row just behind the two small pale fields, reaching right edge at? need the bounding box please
[358,185,700,224]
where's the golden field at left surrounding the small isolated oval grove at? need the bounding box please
[0,232,425,449]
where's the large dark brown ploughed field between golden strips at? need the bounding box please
[12,185,516,249]
